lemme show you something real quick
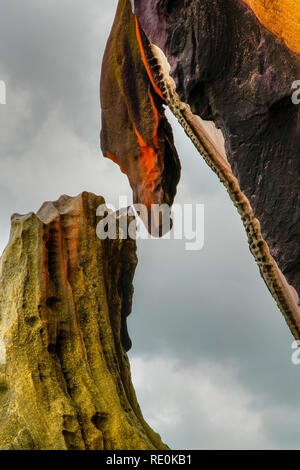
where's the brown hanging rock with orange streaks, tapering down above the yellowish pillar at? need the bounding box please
[101,0,180,231]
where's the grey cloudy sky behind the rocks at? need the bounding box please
[0,0,300,449]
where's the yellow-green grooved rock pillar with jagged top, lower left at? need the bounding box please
[0,193,166,450]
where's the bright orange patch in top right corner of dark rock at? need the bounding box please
[242,0,300,54]
